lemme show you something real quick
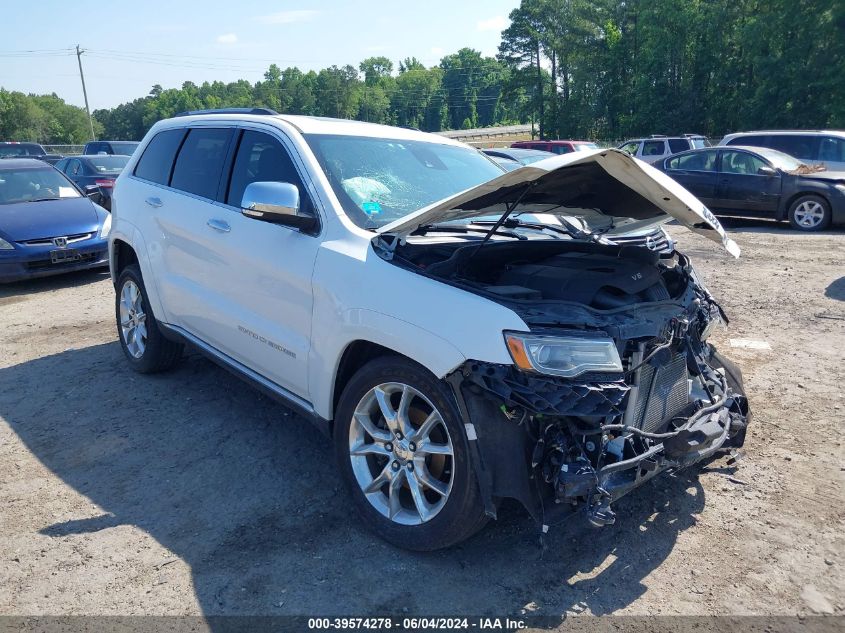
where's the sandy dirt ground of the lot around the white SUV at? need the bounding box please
[0,221,845,616]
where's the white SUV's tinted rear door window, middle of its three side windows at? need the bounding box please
[170,128,232,200]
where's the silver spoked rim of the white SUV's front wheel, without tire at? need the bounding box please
[349,383,454,525]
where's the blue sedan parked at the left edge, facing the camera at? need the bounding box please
[0,158,111,282]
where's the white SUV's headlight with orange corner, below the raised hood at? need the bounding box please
[505,332,622,378]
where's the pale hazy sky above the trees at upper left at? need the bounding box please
[0,0,519,110]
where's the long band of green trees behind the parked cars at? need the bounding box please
[0,0,845,143]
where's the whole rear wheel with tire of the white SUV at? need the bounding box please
[115,264,183,374]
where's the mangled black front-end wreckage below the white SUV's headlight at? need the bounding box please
[448,346,751,525]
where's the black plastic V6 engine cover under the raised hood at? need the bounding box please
[498,253,669,309]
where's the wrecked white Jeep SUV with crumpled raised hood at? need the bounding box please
[109,110,748,550]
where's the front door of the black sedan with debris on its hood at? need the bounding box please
[714,149,781,215]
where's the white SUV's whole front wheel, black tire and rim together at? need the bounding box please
[334,356,487,551]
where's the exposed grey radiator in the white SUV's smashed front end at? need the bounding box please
[634,354,689,433]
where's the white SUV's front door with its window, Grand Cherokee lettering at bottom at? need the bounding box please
[198,129,320,399]
